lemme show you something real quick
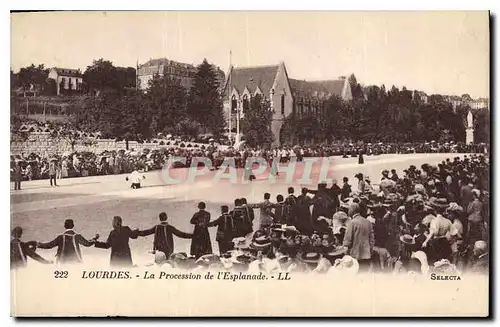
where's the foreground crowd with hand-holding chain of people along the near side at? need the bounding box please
[11,154,490,275]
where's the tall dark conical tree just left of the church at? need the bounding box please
[188,59,225,137]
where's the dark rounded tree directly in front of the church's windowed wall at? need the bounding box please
[241,94,273,147]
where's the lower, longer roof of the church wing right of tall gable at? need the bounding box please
[289,78,345,98]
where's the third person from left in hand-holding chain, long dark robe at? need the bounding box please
[95,216,139,268]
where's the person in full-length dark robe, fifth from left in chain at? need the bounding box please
[191,202,212,259]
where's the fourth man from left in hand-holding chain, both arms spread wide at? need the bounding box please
[138,212,193,258]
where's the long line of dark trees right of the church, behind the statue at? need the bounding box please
[283,75,489,144]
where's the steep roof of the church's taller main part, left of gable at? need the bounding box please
[226,65,279,95]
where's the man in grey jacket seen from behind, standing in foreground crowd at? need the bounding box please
[343,203,375,271]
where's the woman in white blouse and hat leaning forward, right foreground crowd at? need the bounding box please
[422,198,452,262]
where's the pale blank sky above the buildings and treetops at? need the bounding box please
[11,11,490,98]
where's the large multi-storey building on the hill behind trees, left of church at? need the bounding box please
[137,58,224,90]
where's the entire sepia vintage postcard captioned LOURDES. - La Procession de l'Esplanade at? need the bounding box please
[10,11,491,317]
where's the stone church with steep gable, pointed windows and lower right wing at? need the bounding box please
[224,62,352,145]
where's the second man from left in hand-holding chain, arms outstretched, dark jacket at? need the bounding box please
[37,219,99,264]
